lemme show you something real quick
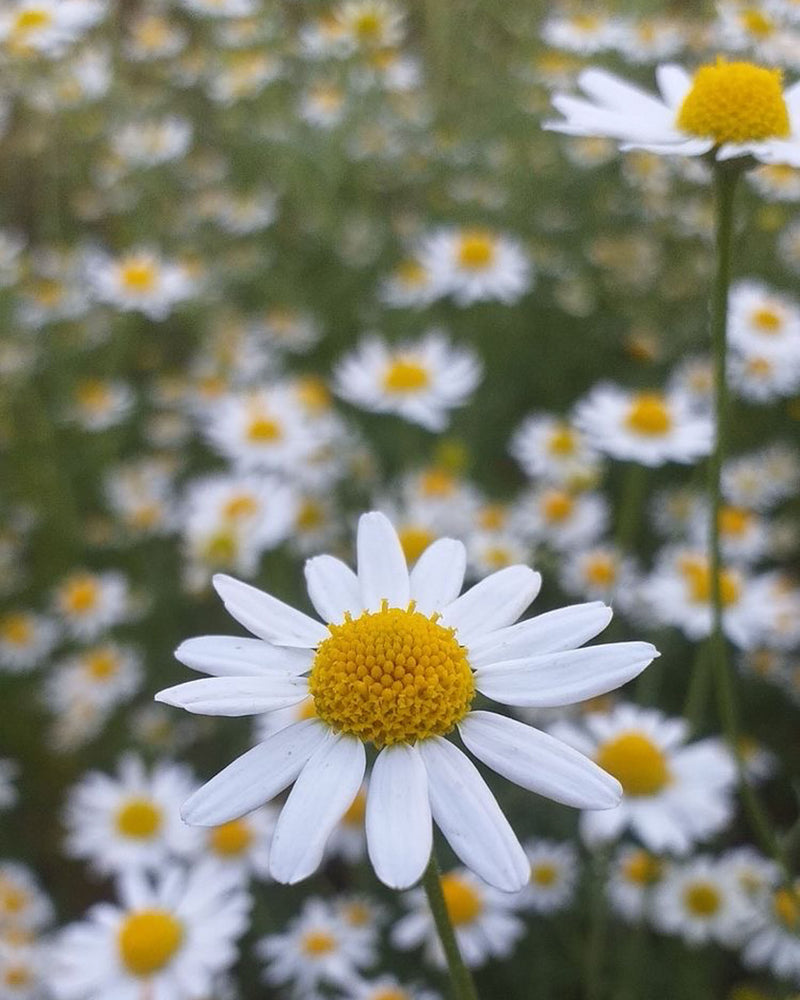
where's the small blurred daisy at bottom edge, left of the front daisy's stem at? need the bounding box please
[256,897,377,996]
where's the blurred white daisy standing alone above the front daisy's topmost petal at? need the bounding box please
[333,330,482,431]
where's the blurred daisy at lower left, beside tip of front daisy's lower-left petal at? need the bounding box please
[64,755,201,874]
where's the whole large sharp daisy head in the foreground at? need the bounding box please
[156,512,658,891]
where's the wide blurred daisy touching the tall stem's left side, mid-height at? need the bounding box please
[575,383,714,466]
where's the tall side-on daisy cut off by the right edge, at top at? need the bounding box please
[545,58,800,166]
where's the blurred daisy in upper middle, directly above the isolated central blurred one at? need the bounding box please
[417,228,533,306]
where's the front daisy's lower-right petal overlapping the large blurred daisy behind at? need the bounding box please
[458,712,622,809]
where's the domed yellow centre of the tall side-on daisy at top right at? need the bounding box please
[676,59,790,145]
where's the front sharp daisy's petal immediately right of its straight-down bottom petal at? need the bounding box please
[419,736,531,892]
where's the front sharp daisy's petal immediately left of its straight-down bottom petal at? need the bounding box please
[269,736,367,885]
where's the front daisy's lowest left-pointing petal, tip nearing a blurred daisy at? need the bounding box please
[181,719,330,826]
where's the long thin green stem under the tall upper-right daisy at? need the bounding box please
[707,162,787,872]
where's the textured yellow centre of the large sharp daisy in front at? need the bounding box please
[309,601,475,746]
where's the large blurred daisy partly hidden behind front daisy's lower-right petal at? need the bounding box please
[550,704,736,854]
